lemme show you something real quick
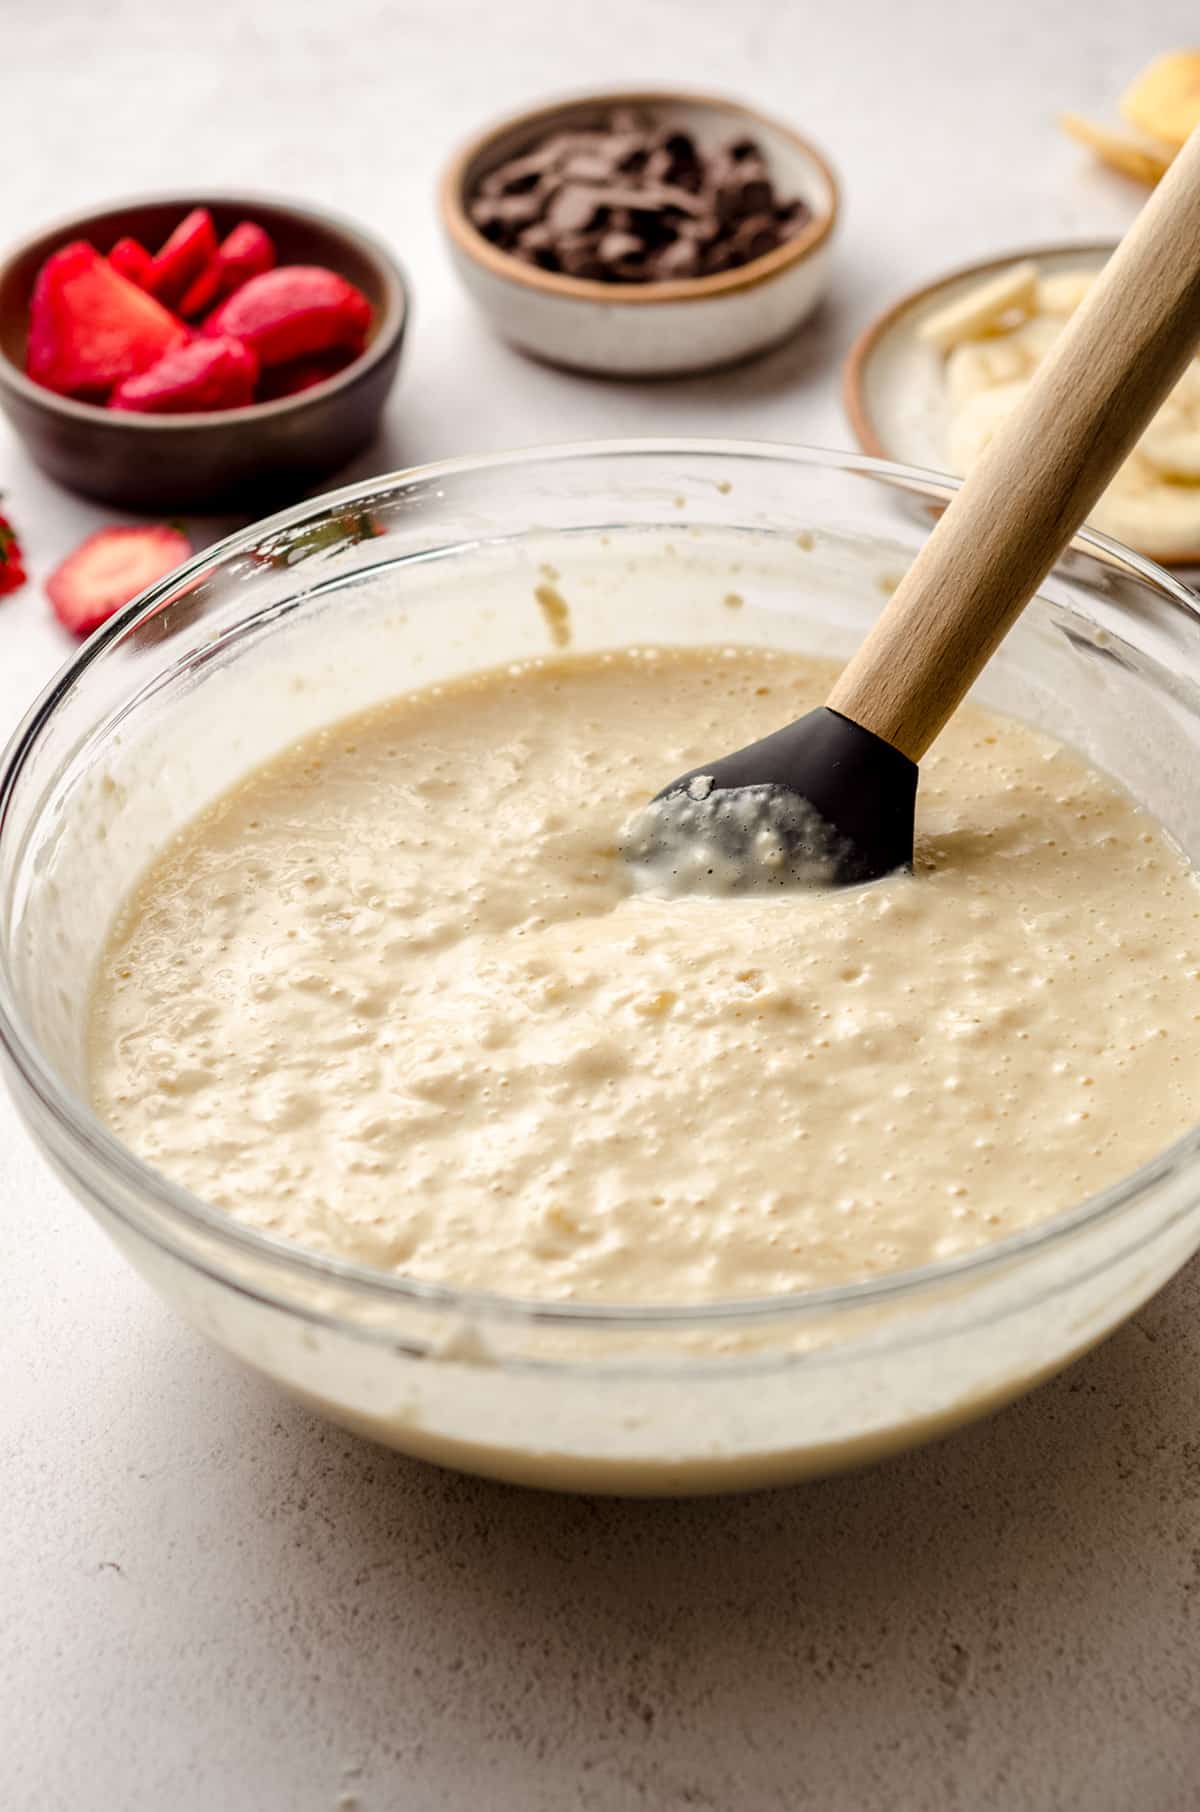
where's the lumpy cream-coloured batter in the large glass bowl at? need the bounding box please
[91,649,1200,1303]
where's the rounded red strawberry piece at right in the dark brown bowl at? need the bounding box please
[201,265,372,366]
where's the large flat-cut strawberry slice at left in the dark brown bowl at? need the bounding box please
[25,239,187,399]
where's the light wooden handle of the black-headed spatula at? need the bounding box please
[828,129,1200,761]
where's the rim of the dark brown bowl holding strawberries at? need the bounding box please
[0,188,410,433]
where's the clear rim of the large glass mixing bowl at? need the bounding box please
[0,437,1200,1332]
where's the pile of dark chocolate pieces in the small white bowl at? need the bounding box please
[468,107,812,283]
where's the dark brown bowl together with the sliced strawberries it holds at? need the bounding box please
[0,192,408,510]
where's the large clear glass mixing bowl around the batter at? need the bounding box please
[0,442,1200,1493]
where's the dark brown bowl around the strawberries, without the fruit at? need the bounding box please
[0,194,408,515]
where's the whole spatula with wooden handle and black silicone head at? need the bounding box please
[625,127,1200,892]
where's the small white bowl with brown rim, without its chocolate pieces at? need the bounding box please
[440,92,837,377]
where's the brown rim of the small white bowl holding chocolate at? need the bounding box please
[439,89,839,306]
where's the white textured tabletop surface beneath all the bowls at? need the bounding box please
[0,0,1200,1812]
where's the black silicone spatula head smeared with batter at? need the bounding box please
[624,705,917,893]
